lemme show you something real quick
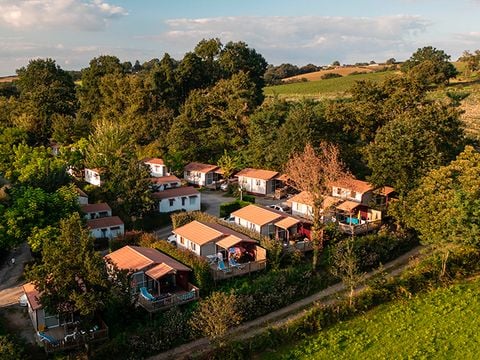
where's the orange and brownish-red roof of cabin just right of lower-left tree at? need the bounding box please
[105,245,191,271]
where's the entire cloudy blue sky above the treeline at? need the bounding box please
[0,0,480,76]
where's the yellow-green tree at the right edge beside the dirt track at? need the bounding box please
[394,146,480,274]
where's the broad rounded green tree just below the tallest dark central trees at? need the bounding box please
[168,72,255,162]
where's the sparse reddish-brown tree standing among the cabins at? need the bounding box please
[285,143,349,269]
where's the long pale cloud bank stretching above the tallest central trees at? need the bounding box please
[148,15,431,64]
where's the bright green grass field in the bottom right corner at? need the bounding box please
[258,280,480,360]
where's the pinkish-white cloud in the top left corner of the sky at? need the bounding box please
[0,0,127,30]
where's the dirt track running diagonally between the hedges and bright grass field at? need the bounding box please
[149,246,421,360]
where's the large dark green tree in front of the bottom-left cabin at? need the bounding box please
[27,213,109,328]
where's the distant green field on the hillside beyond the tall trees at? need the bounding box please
[263,71,394,99]
